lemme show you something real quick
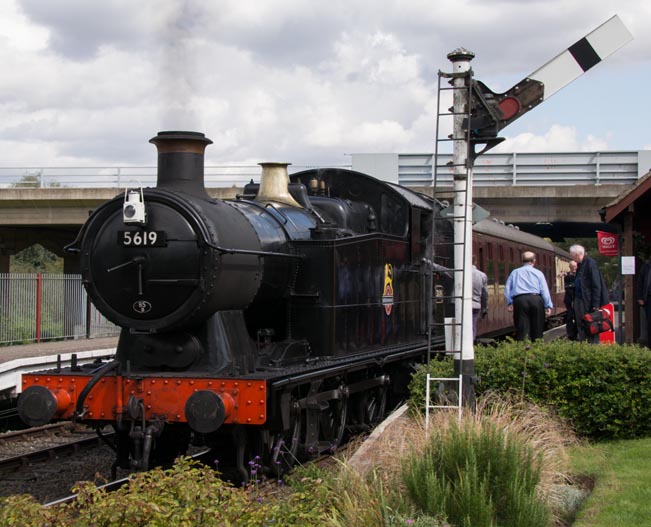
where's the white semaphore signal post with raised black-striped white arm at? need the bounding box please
[426,15,633,420]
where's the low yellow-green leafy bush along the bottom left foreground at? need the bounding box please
[0,458,331,527]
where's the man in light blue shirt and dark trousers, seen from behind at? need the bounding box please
[504,251,553,341]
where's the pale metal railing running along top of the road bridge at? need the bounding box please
[0,151,640,188]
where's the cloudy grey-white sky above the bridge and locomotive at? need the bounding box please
[0,0,651,167]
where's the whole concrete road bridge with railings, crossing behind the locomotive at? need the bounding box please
[0,150,651,273]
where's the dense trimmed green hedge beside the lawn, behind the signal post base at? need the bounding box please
[410,341,651,439]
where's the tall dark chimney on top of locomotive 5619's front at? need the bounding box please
[149,132,212,197]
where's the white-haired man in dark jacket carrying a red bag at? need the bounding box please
[570,245,608,344]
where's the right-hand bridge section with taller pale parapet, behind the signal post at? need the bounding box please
[352,150,651,240]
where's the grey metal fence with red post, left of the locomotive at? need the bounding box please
[0,273,119,345]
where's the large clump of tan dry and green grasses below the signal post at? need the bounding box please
[328,394,576,527]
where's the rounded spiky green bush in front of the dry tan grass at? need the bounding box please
[404,420,550,527]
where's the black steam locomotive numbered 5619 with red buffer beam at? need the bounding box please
[18,132,572,479]
